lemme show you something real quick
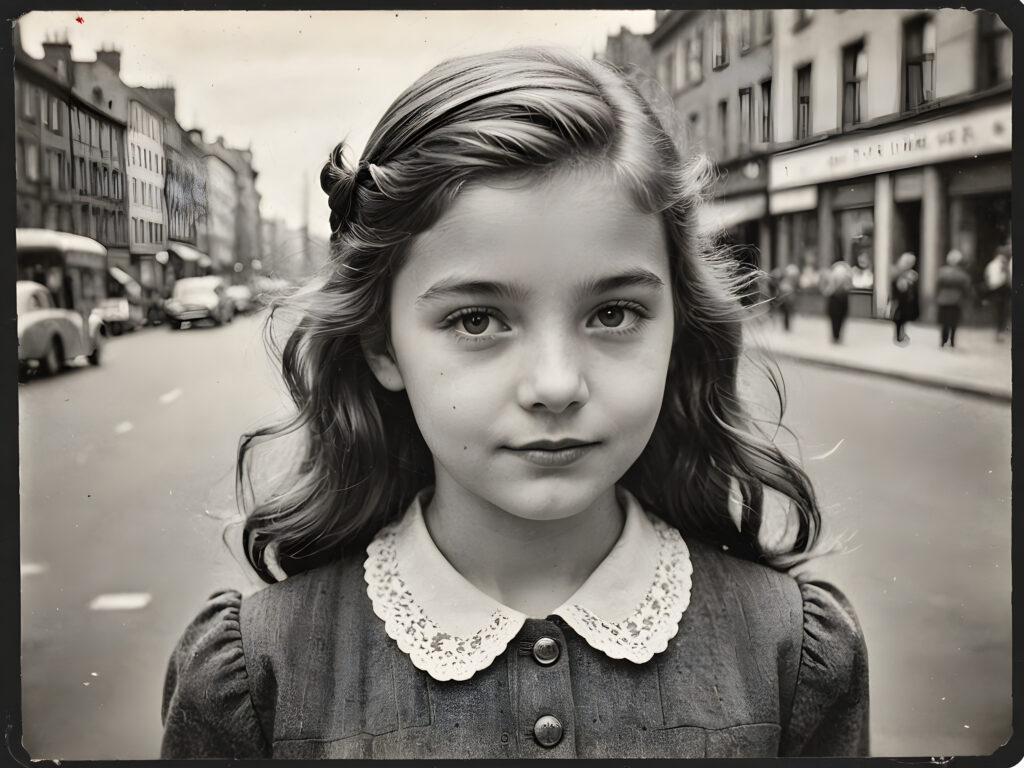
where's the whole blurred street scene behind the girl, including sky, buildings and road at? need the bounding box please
[13,9,1012,760]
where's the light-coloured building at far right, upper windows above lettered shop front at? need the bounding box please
[769,9,1012,319]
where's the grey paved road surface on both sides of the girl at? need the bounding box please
[19,317,1011,760]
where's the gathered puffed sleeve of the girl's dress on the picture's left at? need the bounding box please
[160,590,270,759]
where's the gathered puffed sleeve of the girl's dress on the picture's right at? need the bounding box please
[781,582,869,757]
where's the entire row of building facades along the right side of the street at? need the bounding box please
[634,8,1012,319]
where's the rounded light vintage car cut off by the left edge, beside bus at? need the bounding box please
[15,280,104,376]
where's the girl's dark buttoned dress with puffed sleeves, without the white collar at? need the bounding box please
[162,542,868,759]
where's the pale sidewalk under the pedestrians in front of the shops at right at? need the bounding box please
[744,313,1013,401]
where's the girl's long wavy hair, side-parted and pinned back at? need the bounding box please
[237,48,820,581]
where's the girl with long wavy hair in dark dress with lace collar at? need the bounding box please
[163,49,867,758]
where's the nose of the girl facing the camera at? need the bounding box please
[518,340,590,414]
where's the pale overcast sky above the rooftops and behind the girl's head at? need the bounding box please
[18,10,654,237]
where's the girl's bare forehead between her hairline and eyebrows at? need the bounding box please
[398,171,669,290]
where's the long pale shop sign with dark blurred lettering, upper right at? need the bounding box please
[768,103,1012,189]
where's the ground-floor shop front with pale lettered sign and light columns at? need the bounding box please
[768,98,1012,322]
